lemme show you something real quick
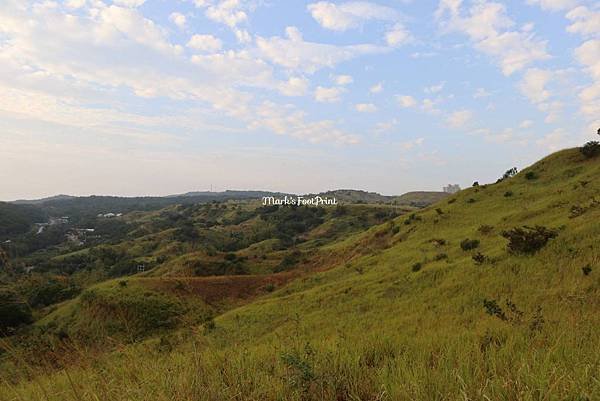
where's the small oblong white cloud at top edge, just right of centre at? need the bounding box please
[307,1,399,31]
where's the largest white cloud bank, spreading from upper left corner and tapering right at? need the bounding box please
[0,2,359,148]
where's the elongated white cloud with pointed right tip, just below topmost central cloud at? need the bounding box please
[256,27,387,74]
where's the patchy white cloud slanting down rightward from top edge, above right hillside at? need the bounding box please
[436,0,550,75]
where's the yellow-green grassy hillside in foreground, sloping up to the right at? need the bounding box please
[0,149,600,401]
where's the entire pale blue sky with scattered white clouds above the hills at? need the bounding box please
[0,0,600,200]
